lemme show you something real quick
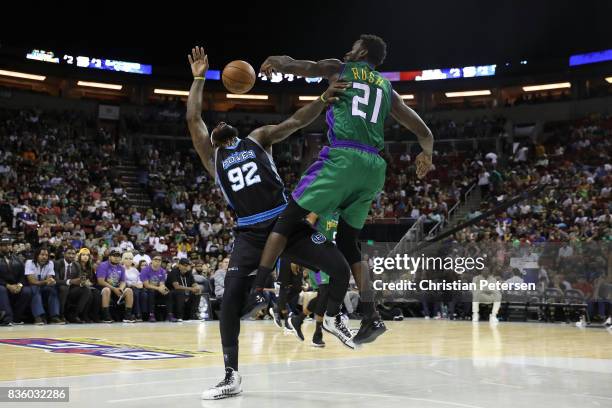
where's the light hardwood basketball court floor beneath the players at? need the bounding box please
[0,319,612,408]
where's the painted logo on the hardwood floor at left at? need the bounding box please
[0,338,209,361]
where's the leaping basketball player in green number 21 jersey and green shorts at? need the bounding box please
[255,35,433,344]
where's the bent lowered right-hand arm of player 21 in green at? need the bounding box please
[391,91,434,178]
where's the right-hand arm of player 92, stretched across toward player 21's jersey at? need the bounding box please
[250,82,349,149]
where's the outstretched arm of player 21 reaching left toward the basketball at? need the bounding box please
[259,55,342,79]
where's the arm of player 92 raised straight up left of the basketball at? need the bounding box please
[186,47,215,177]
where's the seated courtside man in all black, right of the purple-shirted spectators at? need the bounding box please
[166,258,202,322]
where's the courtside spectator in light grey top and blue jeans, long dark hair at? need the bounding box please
[25,247,66,325]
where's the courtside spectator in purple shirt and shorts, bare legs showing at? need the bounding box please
[96,250,136,323]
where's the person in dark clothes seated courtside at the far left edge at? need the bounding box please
[0,237,32,326]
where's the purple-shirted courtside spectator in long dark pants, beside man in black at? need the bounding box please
[140,253,177,322]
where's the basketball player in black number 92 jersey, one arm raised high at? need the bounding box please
[187,47,355,399]
